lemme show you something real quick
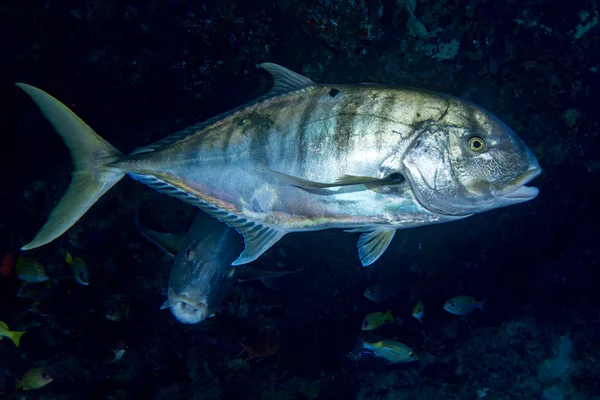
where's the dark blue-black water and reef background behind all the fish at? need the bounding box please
[0,0,600,399]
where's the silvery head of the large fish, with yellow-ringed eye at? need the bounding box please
[402,100,542,217]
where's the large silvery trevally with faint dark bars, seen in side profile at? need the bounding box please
[17,63,541,265]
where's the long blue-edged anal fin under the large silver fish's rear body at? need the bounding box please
[129,173,287,266]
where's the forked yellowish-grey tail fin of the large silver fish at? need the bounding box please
[16,83,124,250]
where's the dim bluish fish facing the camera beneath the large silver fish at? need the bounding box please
[137,212,300,324]
